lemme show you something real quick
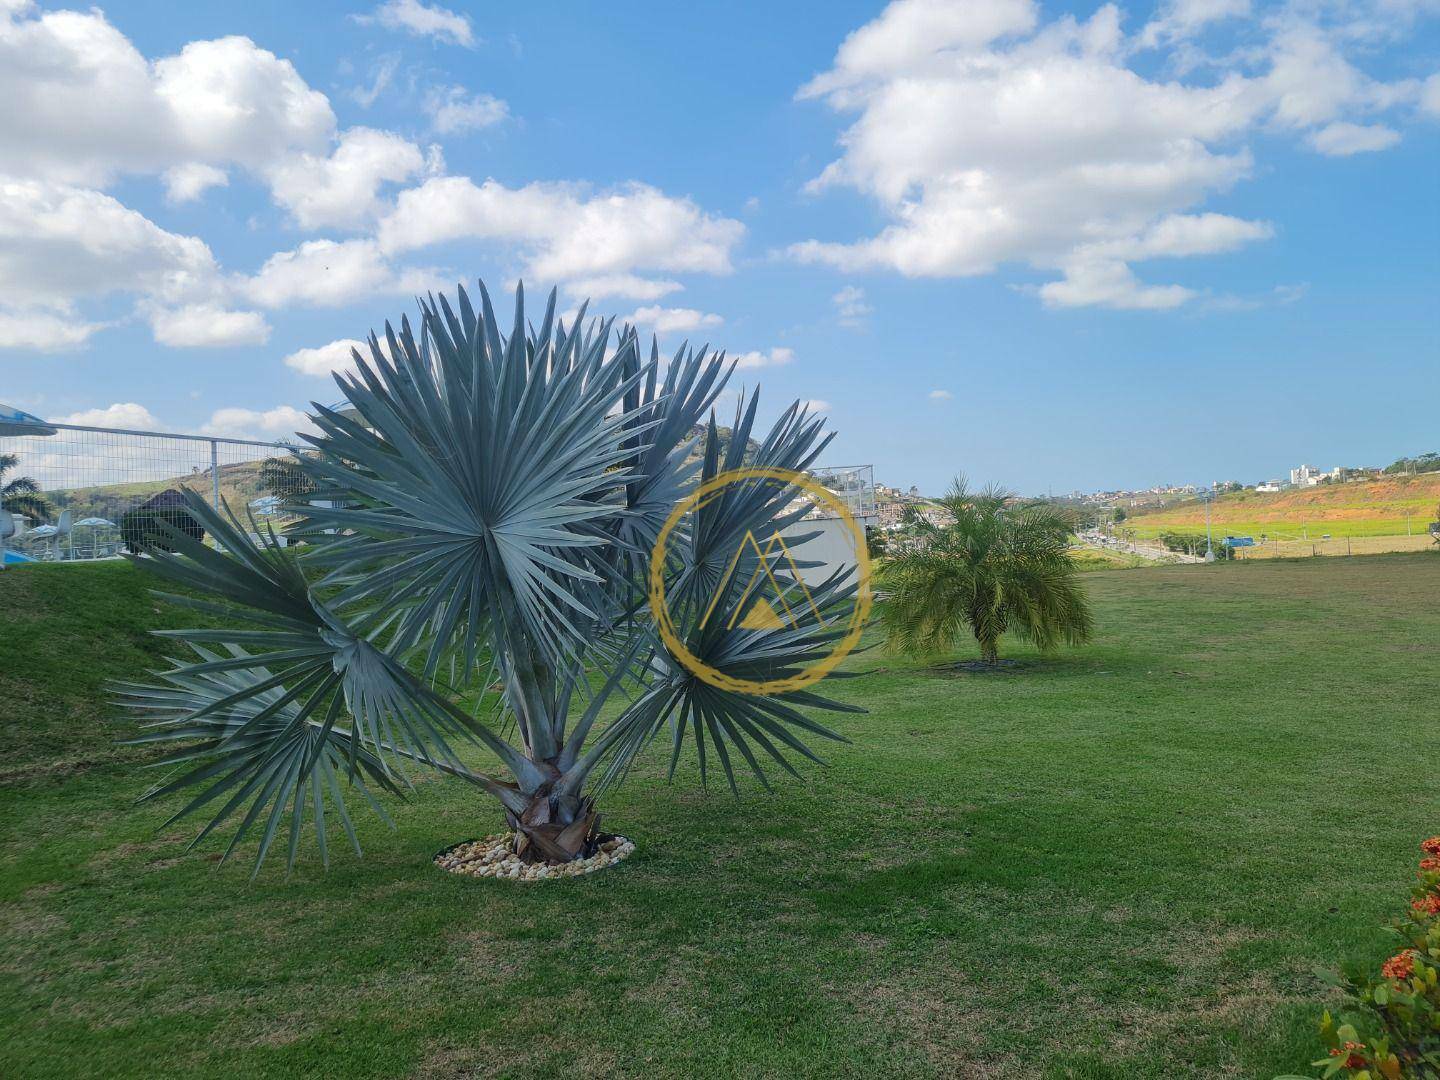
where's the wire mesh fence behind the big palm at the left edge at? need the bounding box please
[0,423,305,562]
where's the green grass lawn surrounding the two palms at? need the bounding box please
[0,554,1440,1080]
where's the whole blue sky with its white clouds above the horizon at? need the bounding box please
[0,0,1440,492]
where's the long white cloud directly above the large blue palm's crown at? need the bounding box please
[379,176,744,281]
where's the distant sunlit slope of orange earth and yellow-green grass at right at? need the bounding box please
[1125,472,1440,540]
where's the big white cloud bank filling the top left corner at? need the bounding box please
[0,4,426,348]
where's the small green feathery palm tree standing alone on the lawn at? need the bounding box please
[880,477,1092,664]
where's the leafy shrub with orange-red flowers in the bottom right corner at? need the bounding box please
[1280,837,1440,1080]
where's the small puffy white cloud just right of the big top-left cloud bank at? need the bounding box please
[266,128,425,229]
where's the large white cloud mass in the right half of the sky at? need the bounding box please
[789,0,1427,308]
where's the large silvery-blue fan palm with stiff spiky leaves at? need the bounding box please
[120,284,861,873]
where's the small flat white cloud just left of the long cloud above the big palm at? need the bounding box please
[238,239,445,308]
